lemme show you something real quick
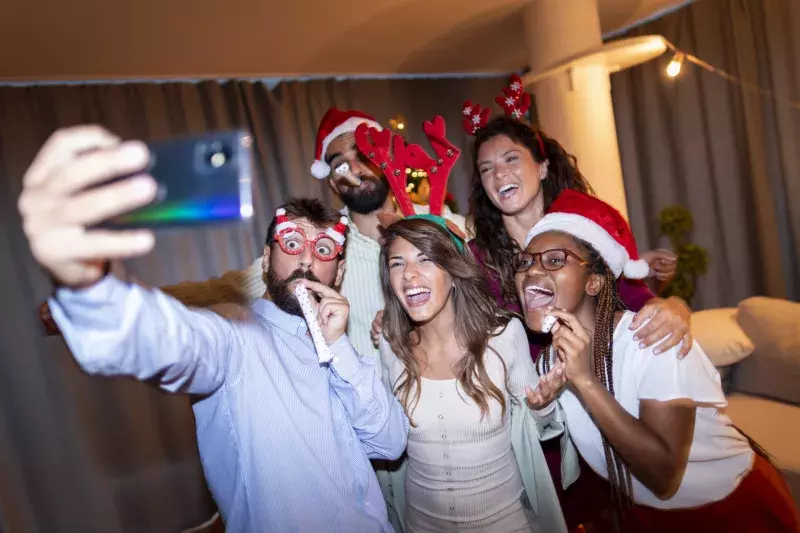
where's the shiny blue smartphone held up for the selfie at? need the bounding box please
[101,131,253,229]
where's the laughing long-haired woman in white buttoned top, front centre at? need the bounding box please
[380,215,563,533]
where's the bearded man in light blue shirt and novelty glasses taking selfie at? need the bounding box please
[19,126,408,532]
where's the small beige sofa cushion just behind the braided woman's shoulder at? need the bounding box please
[692,307,754,368]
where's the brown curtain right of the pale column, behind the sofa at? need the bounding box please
[612,0,800,308]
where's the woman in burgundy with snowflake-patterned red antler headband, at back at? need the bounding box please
[463,76,692,528]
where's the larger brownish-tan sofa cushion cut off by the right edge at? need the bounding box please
[733,297,800,404]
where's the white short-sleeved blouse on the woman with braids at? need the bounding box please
[548,312,753,509]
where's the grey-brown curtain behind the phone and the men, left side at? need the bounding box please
[0,74,505,533]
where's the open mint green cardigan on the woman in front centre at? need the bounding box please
[375,380,579,533]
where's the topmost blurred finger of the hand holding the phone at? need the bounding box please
[23,126,120,187]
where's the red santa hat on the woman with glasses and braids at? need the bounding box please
[525,189,650,279]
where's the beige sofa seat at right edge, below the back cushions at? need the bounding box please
[728,393,800,508]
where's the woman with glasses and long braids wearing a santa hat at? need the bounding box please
[516,191,798,533]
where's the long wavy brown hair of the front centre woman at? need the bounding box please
[380,219,511,424]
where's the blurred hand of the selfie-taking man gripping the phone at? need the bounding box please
[18,126,157,287]
